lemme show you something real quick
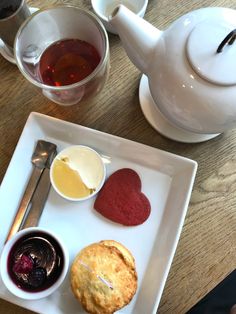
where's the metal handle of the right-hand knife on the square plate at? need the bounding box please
[21,168,51,229]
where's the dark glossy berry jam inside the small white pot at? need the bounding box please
[7,231,64,292]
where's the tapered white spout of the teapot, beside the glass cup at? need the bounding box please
[109,5,162,75]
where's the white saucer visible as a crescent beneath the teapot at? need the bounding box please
[139,74,220,143]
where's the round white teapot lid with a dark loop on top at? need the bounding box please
[187,20,236,85]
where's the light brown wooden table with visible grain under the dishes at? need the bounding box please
[0,0,236,314]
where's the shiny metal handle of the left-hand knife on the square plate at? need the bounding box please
[6,167,43,242]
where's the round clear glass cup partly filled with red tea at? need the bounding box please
[14,5,109,106]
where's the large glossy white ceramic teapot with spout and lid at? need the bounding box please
[109,5,236,142]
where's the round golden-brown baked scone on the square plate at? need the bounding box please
[71,240,137,314]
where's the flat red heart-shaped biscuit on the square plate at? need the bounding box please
[94,168,151,226]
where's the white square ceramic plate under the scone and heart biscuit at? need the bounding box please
[0,113,197,314]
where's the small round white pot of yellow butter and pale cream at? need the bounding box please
[50,145,105,200]
